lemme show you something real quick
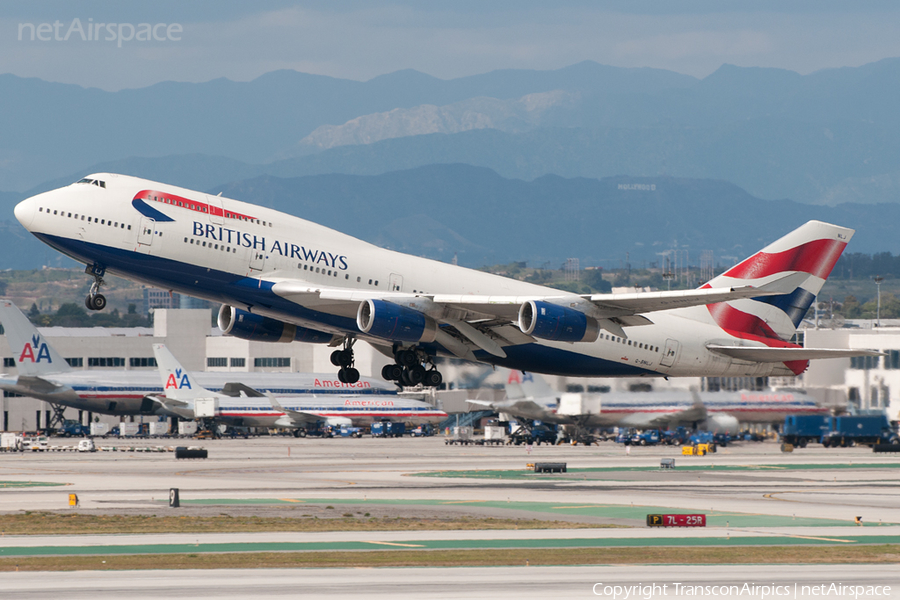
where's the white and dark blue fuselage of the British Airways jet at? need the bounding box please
[16,174,791,377]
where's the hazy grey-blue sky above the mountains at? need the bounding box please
[0,0,900,90]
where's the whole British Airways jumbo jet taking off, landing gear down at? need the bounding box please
[15,173,878,386]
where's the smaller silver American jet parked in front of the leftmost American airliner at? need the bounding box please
[153,344,447,429]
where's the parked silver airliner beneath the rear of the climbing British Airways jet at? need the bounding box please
[469,371,828,433]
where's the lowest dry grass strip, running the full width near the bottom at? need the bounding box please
[0,544,900,572]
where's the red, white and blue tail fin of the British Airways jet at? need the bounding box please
[703,221,854,342]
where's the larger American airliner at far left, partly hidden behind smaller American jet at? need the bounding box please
[0,299,397,415]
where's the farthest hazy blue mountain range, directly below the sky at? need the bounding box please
[0,59,900,205]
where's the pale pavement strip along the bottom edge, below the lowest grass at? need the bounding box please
[2,565,900,600]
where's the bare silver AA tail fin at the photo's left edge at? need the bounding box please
[0,299,72,376]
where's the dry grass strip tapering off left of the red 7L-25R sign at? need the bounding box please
[0,512,625,535]
